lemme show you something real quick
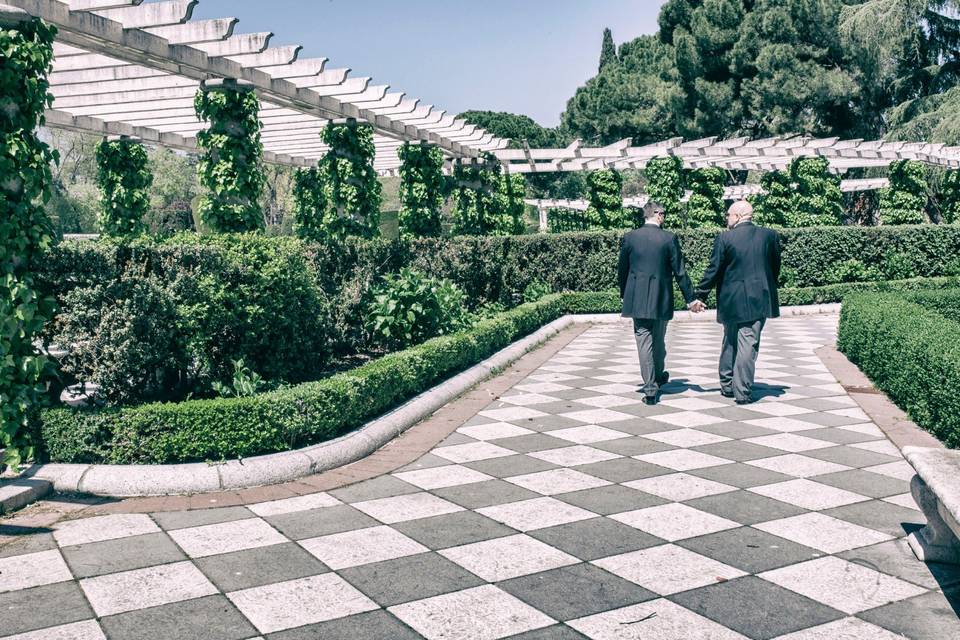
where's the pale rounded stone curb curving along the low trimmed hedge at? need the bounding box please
[23,305,840,498]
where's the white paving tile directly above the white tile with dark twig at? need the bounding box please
[593,544,746,596]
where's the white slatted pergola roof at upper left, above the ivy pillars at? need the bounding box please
[4,0,508,172]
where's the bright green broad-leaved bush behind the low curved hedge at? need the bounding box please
[368,269,468,349]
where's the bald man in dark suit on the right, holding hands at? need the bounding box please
[697,200,780,404]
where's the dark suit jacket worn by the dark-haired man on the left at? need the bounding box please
[617,225,694,320]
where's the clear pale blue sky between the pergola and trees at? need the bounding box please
[194,0,663,126]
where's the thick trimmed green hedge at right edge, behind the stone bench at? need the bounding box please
[838,290,960,448]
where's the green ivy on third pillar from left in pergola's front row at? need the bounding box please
[318,120,381,238]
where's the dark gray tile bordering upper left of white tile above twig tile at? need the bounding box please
[527,518,663,561]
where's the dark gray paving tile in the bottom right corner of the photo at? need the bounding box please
[857,589,960,640]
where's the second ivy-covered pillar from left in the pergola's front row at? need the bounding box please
[194,78,266,233]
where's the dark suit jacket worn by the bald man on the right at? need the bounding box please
[697,222,780,324]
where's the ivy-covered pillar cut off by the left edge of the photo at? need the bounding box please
[0,4,58,467]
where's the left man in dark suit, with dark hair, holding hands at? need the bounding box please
[617,201,702,404]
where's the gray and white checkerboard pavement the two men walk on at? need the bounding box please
[0,316,960,640]
